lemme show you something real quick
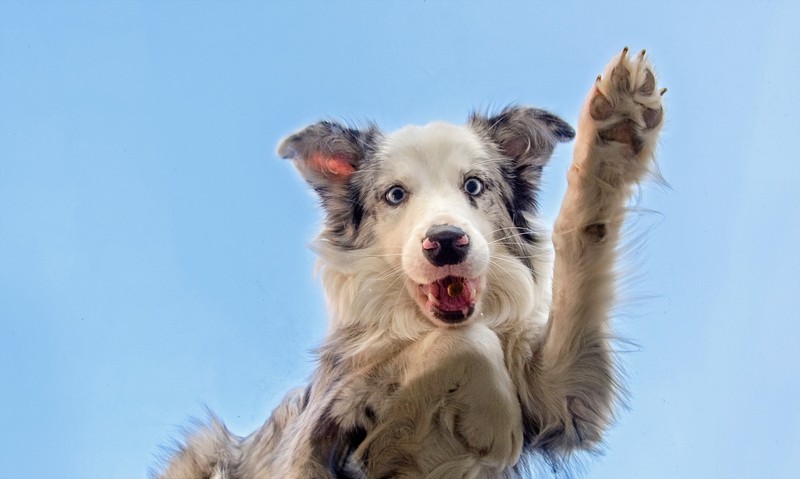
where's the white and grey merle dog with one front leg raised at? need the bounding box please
[158,48,666,479]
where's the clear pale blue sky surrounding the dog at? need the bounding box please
[0,1,800,479]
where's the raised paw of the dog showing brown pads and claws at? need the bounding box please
[578,47,666,188]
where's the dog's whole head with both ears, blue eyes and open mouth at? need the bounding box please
[278,107,574,326]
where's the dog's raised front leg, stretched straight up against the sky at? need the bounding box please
[526,48,663,454]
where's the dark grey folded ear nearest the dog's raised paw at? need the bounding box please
[469,106,575,167]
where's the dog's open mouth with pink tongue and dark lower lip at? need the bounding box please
[419,276,479,324]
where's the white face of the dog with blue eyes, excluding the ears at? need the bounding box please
[375,123,499,325]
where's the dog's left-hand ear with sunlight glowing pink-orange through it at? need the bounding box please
[278,121,379,189]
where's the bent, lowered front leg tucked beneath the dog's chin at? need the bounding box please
[356,324,522,479]
